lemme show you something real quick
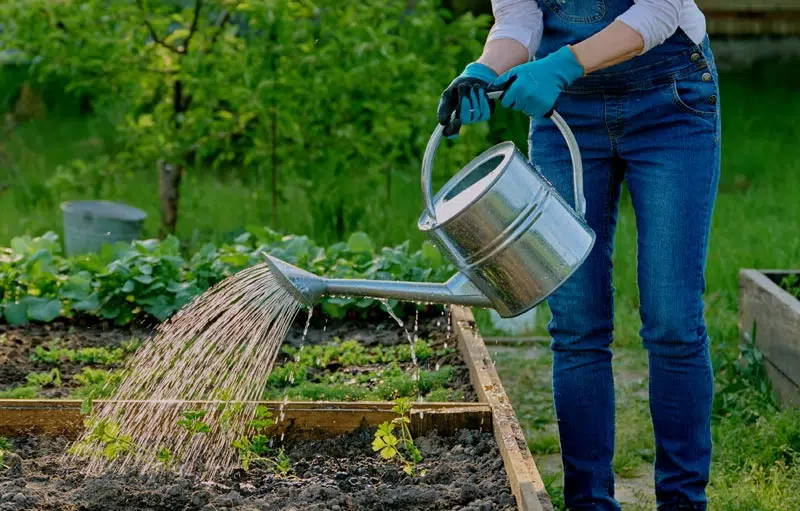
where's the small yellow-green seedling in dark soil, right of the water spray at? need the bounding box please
[372,399,426,476]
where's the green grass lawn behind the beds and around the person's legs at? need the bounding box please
[0,57,800,511]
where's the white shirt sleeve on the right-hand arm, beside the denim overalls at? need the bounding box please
[617,0,683,53]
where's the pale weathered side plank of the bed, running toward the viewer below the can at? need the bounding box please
[452,307,553,511]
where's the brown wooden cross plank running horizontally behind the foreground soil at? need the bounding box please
[0,399,492,439]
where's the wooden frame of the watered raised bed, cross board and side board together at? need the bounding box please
[0,307,553,511]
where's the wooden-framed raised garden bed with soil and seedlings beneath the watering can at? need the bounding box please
[0,307,552,511]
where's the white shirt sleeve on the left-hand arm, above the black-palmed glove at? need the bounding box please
[487,0,543,59]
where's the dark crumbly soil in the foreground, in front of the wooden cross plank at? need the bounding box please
[0,429,516,511]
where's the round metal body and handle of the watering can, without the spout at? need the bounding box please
[418,104,595,318]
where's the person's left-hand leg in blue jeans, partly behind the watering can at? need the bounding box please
[530,94,622,511]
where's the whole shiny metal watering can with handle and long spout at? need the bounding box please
[267,91,595,318]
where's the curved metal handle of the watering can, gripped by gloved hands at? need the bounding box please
[422,91,586,222]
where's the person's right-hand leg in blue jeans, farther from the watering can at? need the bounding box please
[620,38,720,510]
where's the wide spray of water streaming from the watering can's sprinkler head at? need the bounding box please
[65,264,300,477]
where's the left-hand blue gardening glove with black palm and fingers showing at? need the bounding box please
[437,62,497,138]
